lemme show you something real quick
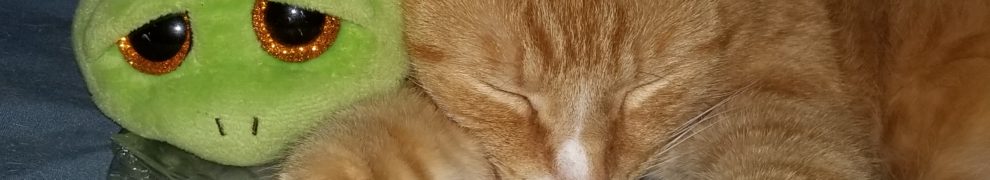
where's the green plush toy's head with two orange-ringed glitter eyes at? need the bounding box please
[73,0,408,166]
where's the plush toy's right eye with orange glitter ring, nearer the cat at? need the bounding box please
[251,0,340,62]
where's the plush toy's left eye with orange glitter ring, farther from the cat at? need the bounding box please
[117,13,192,75]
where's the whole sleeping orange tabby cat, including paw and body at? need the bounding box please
[283,0,990,179]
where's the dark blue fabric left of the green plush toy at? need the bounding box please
[0,0,119,179]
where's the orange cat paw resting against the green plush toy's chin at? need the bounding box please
[279,88,494,180]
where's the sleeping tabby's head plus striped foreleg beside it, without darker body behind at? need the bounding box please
[406,0,879,179]
